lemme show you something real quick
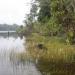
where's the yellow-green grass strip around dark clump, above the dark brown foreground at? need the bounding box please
[27,34,75,62]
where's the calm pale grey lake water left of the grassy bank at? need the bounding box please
[0,33,41,75]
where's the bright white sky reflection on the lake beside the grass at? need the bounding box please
[0,37,24,51]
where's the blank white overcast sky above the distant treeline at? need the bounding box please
[0,0,31,25]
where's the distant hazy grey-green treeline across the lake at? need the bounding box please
[0,24,19,31]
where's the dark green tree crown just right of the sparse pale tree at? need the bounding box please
[36,0,51,23]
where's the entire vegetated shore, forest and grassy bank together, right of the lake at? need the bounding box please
[17,0,75,75]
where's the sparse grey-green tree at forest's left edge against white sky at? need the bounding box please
[25,1,38,33]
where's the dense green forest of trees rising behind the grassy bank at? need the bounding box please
[25,0,75,43]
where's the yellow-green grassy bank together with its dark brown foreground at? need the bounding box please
[26,34,75,75]
